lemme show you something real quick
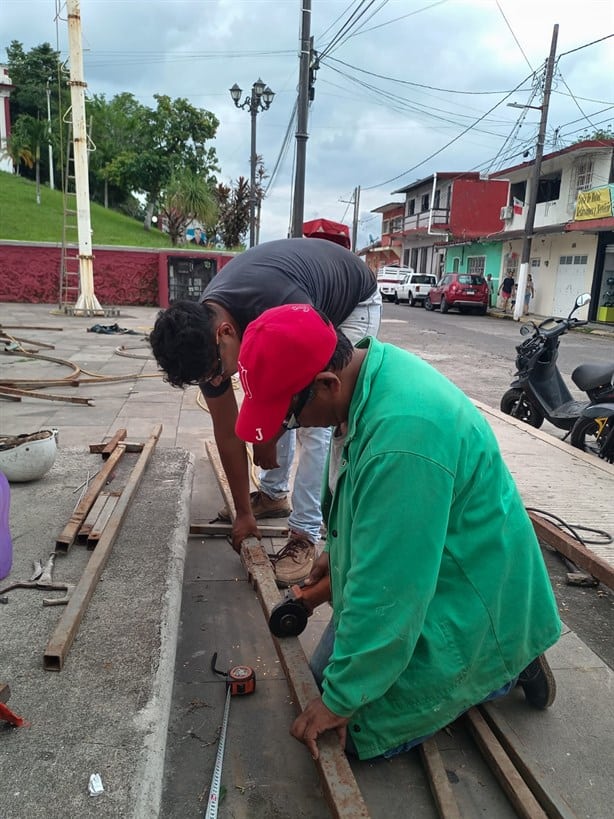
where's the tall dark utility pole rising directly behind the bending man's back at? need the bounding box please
[292,0,311,239]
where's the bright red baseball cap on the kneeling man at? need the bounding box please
[235,304,337,443]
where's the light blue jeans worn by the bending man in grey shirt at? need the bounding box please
[259,290,382,543]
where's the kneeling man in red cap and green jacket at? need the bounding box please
[236,305,561,759]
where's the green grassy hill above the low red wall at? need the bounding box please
[0,171,171,247]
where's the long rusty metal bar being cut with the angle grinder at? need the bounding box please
[205,441,369,819]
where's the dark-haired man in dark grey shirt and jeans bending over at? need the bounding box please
[150,239,381,586]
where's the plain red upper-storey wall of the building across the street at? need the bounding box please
[450,178,509,239]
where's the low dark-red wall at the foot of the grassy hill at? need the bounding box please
[0,242,234,307]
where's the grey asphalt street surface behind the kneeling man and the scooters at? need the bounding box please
[380,304,614,414]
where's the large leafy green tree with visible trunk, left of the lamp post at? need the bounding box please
[108,94,219,229]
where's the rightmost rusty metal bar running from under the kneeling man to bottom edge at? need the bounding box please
[479,703,577,819]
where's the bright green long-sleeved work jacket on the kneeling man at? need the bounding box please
[322,338,561,759]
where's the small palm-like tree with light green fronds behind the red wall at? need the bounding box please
[160,168,217,246]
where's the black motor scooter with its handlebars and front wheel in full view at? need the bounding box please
[501,293,614,436]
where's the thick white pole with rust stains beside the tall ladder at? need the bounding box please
[66,0,104,316]
